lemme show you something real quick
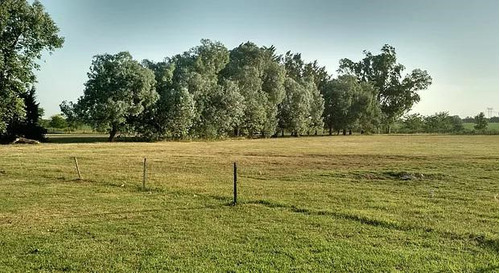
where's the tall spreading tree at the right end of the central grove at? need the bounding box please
[338,45,432,133]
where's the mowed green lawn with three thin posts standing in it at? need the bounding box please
[0,135,499,272]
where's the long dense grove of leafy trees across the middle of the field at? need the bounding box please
[61,40,431,141]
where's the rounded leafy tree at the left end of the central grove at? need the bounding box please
[74,52,158,141]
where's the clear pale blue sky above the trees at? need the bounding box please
[36,0,499,117]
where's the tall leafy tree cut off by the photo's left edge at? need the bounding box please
[0,0,64,138]
